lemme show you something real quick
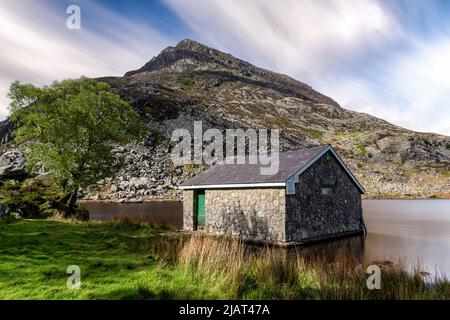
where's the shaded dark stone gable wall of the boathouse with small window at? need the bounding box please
[286,156,363,242]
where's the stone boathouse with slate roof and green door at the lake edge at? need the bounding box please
[180,145,365,245]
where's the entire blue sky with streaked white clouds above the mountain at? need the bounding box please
[0,0,450,135]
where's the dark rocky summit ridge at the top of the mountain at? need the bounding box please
[121,39,338,106]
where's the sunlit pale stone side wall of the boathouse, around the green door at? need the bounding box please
[183,188,286,242]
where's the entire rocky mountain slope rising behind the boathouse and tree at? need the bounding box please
[0,40,450,201]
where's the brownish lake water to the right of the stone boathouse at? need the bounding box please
[302,200,450,278]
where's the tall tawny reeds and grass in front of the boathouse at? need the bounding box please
[139,234,450,299]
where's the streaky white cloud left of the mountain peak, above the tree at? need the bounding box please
[0,0,173,119]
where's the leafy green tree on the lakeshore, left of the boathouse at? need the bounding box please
[9,77,146,213]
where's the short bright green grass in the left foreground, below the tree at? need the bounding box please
[0,220,168,299]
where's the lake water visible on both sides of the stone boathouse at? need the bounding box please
[85,200,450,278]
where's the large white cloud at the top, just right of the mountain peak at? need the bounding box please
[166,0,401,78]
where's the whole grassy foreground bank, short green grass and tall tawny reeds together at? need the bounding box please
[0,219,450,299]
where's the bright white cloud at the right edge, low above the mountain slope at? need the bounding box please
[323,38,450,135]
